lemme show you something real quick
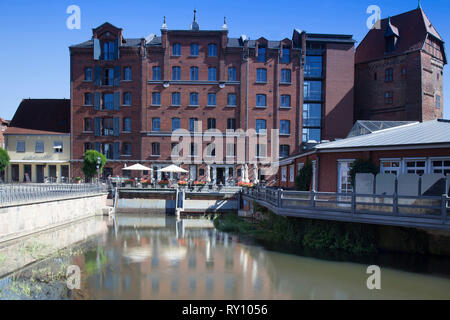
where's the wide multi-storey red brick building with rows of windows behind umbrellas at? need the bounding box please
[70,16,355,183]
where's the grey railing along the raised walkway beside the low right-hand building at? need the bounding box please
[242,188,450,224]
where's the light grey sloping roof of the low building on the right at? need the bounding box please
[316,119,450,150]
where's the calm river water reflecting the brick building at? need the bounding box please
[0,214,450,300]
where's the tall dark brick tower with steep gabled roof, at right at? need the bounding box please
[355,7,447,121]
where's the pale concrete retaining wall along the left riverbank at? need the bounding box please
[0,194,107,242]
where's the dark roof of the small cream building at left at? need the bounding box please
[8,99,70,133]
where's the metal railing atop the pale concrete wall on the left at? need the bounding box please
[0,183,106,207]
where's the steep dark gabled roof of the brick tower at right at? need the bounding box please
[355,8,445,64]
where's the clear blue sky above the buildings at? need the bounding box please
[0,0,450,119]
